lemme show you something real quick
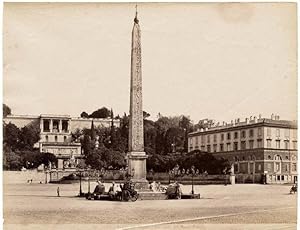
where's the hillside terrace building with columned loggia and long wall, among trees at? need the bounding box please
[3,114,120,169]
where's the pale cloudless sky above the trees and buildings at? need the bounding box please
[3,3,297,122]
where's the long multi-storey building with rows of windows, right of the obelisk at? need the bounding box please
[188,116,297,183]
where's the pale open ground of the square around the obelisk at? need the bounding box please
[4,183,297,230]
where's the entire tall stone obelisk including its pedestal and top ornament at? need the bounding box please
[127,8,148,190]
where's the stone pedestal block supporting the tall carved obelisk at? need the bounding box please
[127,152,150,191]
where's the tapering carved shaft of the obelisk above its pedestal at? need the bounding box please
[129,10,144,152]
